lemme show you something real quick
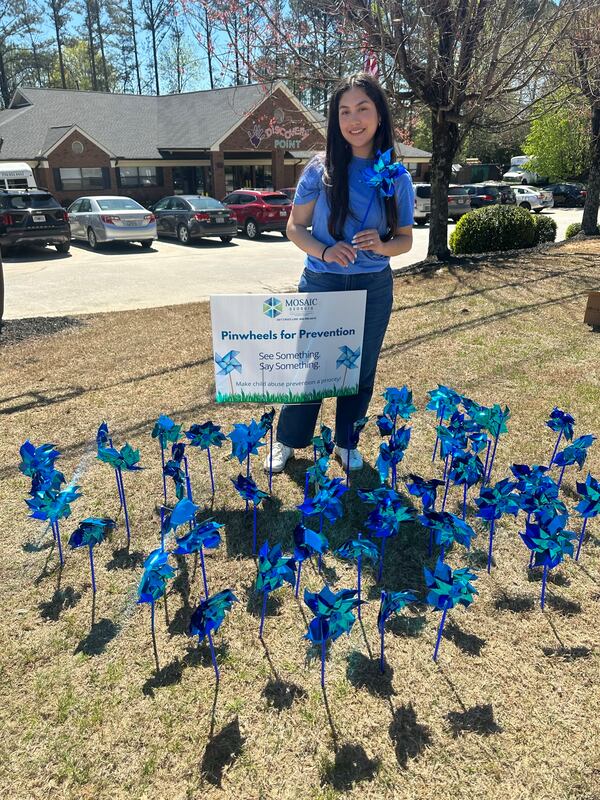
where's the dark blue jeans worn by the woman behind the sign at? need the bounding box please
[277,267,393,447]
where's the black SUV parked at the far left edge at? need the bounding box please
[0,189,71,253]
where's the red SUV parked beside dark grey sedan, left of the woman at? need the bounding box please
[223,189,292,239]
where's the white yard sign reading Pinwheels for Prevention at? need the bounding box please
[210,290,367,403]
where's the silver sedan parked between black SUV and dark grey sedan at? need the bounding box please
[69,195,156,250]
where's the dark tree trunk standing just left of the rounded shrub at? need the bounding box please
[427,111,460,259]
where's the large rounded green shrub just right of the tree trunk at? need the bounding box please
[450,205,536,254]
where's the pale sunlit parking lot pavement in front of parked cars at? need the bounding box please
[4,209,582,319]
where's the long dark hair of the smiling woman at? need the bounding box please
[324,72,398,241]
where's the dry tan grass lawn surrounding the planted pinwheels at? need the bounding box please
[0,242,600,800]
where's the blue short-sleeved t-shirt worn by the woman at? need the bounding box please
[294,156,415,275]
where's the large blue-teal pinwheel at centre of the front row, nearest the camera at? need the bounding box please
[304,586,362,689]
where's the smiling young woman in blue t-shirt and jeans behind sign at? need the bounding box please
[265,72,414,472]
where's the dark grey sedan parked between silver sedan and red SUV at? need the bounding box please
[152,194,237,244]
